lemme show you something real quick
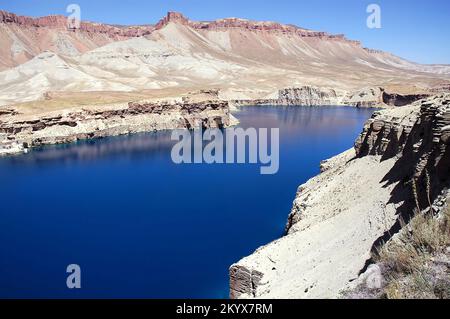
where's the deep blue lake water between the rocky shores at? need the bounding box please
[0,107,373,298]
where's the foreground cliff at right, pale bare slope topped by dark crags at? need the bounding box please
[230,94,450,298]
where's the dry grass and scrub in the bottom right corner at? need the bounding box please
[377,205,450,299]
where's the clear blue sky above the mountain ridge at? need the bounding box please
[0,0,450,64]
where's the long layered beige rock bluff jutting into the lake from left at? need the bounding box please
[0,101,236,153]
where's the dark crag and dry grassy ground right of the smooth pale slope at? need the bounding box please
[343,95,450,299]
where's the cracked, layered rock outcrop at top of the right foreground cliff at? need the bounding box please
[355,94,450,167]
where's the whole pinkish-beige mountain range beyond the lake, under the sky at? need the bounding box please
[0,11,450,104]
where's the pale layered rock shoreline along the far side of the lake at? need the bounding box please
[0,86,434,155]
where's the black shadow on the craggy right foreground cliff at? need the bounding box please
[359,112,450,273]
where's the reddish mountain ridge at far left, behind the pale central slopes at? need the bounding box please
[0,10,154,70]
